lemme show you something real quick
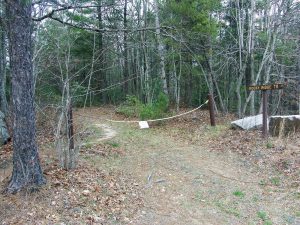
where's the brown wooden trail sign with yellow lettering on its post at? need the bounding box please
[247,84,284,138]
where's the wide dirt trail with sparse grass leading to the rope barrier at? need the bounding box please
[80,108,300,225]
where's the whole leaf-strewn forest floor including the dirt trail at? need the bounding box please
[0,107,300,225]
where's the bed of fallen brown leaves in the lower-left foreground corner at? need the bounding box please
[0,165,143,224]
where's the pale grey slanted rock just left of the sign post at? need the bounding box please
[231,114,262,130]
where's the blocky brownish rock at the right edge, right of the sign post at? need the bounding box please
[269,115,300,136]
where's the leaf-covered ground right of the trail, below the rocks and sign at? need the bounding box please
[156,110,300,180]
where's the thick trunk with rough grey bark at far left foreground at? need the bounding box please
[5,0,46,193]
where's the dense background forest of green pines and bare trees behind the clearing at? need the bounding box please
[1,0,300,117]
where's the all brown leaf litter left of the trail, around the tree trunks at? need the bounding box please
[0,108,143,225]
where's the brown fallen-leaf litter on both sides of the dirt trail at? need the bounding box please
[0,109,300,224]
